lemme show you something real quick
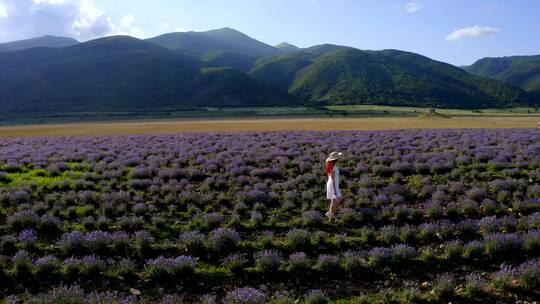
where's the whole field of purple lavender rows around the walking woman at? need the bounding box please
[0,129,540,303]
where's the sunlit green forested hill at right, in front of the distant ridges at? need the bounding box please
[250,49,530,108]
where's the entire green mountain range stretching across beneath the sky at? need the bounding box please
[0,28,540,112]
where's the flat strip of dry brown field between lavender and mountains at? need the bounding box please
[0,117,539,137]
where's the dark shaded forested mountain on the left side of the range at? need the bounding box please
[0,36,294,112]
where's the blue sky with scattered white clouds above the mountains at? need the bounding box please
[0,0,540,65]
